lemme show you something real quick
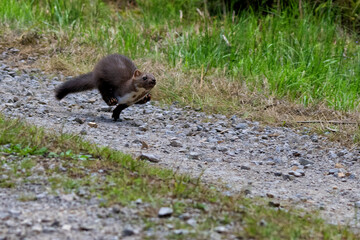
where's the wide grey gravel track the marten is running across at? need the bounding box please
[0,51,360,233]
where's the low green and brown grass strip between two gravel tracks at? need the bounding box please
[0,116,359,239]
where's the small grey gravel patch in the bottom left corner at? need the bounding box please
[0,184,143,240]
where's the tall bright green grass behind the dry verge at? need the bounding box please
[0,0,360,110]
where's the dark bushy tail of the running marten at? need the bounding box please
[55,72,96,100]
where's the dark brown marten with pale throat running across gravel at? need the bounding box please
[55,54,156,121]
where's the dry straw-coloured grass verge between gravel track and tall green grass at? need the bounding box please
[0,29,360,147]
